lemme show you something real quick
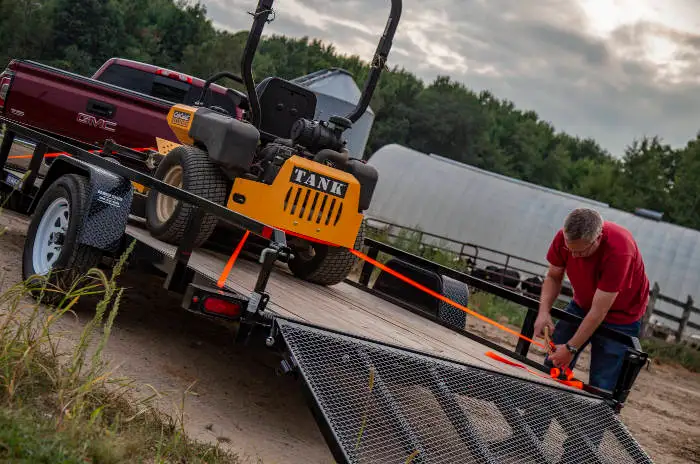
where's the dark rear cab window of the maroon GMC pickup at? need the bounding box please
[97,64,192,103]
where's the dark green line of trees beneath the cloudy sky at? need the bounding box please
[0,0,700,229]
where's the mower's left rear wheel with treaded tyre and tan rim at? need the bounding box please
[146,145,228,247]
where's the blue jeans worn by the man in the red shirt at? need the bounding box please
[544,300,641,391]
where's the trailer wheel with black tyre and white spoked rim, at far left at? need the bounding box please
[22,174,102,304]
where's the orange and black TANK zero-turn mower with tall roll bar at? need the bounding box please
[146,0,401,285]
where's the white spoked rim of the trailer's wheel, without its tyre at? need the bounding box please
[32,198,70,276]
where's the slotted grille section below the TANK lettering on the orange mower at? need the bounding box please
[284,186,343,226]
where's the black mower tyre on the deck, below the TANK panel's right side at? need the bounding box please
[288,221,365,286]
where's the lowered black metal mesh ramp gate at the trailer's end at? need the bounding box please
[276,319,652,464]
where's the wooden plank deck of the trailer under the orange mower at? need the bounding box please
[127,219,584,394]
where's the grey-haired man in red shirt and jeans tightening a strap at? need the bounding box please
[535,208,649,391]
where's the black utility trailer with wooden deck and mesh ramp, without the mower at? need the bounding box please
[0,120,651,463]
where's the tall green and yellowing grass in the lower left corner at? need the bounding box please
[0,237,238,464]
